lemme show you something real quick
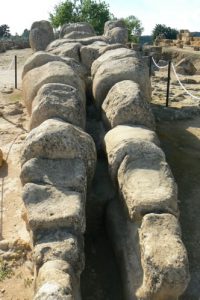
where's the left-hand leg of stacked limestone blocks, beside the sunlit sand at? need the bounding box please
[21,20,101,300]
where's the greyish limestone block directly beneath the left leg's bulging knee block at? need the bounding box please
[20,158,87,194]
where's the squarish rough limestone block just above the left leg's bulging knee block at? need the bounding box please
[30,83,86,129]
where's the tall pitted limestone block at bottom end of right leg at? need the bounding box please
[137,214,189,300]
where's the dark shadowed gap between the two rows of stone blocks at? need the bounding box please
[81,98,123,300]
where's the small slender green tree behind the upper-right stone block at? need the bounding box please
[124,15,144,42]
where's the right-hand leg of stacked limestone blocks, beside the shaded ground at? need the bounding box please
[92,49,189,300]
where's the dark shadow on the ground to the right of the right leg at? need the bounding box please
[157,117,200,300]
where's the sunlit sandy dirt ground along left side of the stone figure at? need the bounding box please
[0,49,33,300]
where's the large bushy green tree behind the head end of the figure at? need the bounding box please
[50,0,112,34]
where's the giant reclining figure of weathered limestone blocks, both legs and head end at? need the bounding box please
[21,20,189,300]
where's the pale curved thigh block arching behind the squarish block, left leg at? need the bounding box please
[22,61,85,114]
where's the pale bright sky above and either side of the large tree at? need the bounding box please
[0,0,200,35]
